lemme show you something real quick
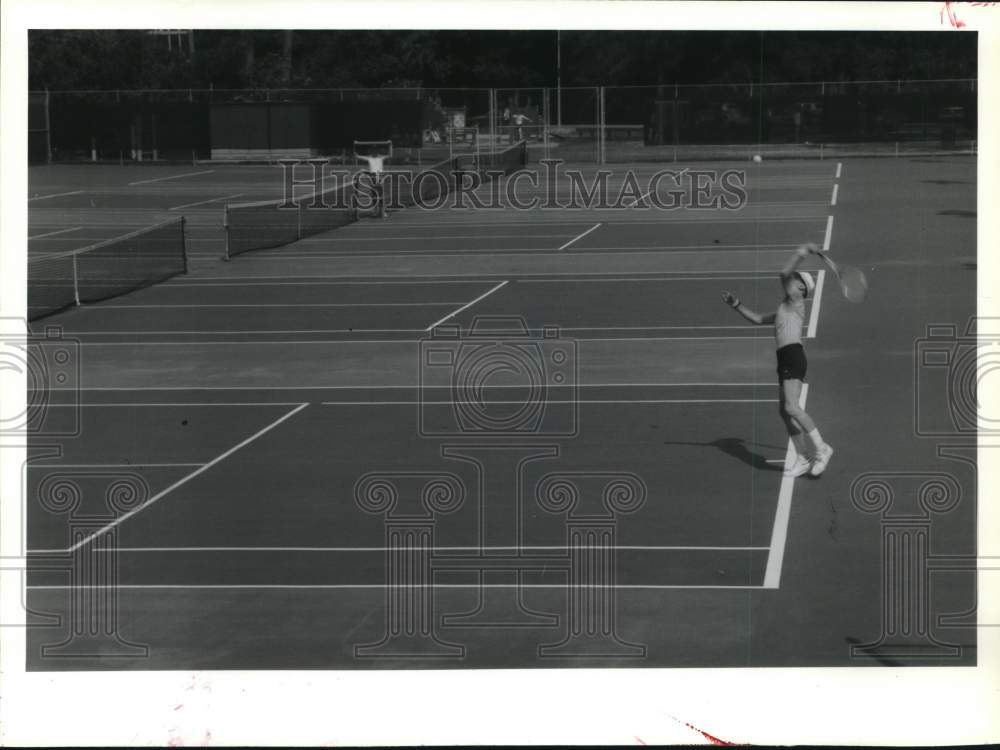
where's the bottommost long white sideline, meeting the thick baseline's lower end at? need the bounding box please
[25,584,765,591]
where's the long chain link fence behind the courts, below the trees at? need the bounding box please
[28,79,977,164]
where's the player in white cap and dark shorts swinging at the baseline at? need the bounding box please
[722,242,833,477]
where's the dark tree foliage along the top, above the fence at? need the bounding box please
[29,30,977,90]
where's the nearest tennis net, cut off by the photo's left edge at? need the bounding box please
[28,217,187,320]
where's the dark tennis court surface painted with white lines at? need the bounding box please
[23,157,976,670]
